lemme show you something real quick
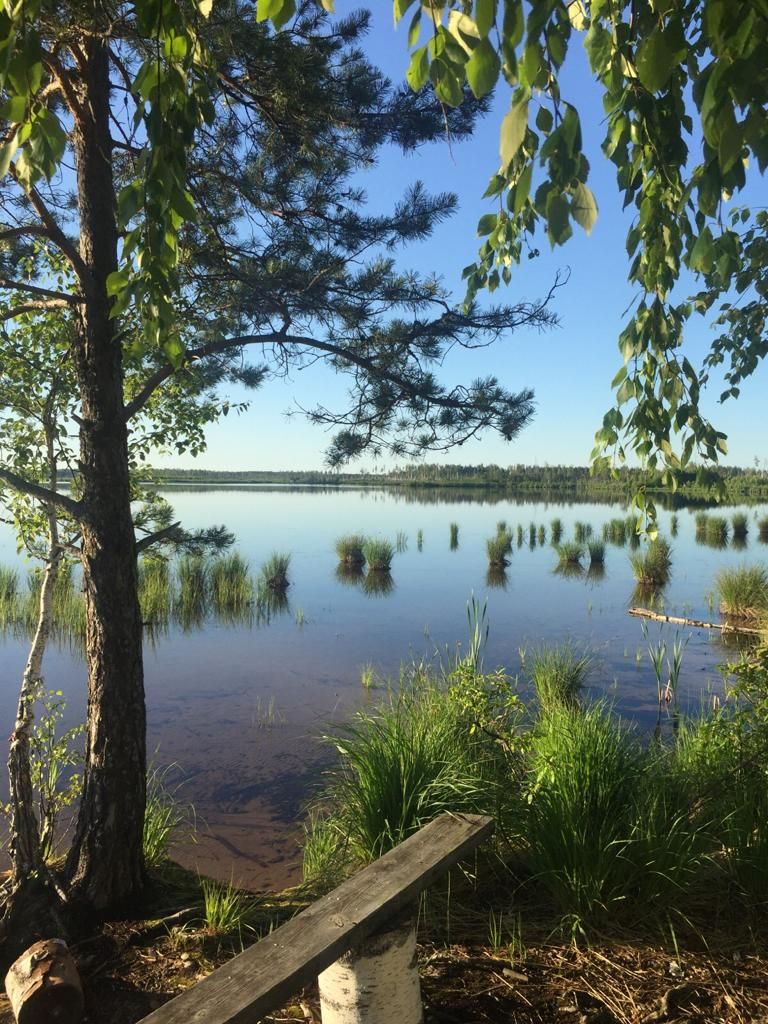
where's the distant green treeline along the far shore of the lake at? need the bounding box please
[103,463,768,504]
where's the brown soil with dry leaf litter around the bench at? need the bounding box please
[0,900,768,1024]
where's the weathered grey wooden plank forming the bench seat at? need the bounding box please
[140,814,494,1024]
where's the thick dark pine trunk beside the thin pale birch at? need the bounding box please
[68,28,146,909]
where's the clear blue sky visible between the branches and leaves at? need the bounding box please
[154,6,768,469]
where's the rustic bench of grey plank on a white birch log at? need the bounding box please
[141,814,494,1024]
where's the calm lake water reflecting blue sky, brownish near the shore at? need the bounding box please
[0,487,768,888]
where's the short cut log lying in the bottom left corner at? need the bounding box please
[5,939,83,1024]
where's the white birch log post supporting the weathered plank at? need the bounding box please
[317,921,424,1024]
